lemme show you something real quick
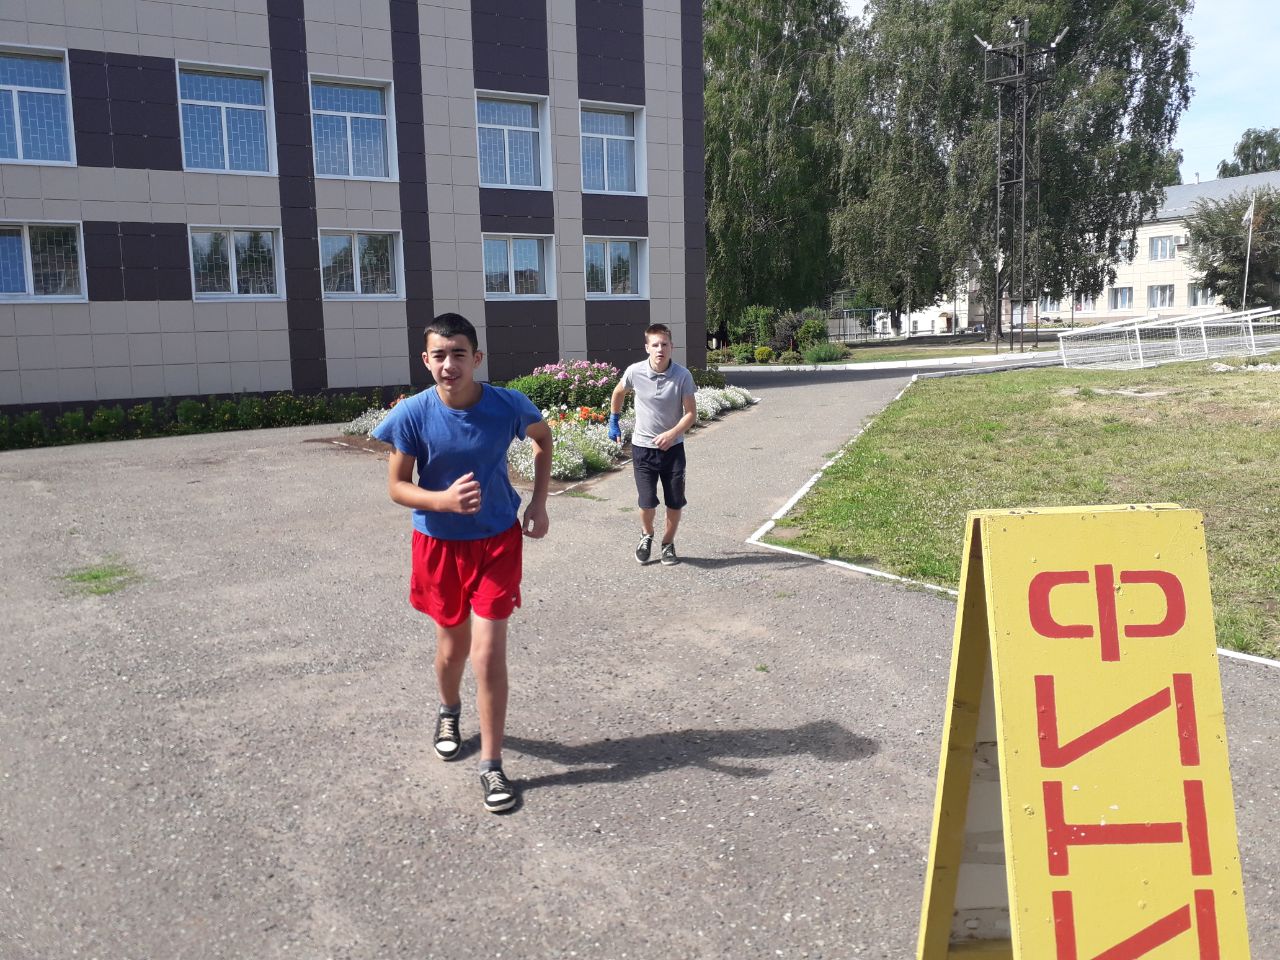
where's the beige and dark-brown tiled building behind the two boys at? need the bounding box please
[0,0,705,406]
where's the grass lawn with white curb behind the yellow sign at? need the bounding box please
[769,355,1280,657]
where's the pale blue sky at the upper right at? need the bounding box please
[845,0,1280,183]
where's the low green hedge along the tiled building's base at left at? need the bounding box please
[0,390,384,449]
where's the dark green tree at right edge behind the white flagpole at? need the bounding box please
[1187,188,1280,310]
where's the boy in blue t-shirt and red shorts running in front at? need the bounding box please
[372,314,552,813]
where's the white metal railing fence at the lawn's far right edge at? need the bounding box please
[1059,307,1280,370]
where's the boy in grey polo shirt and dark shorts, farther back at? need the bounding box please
[609,324,698,564]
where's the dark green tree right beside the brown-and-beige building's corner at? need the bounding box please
[704,0,846,334]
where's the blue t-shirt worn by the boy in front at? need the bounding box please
[370,384,543,540]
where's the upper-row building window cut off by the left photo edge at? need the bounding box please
[0,52,72,164]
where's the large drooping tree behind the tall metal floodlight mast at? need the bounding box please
[833,0,1190,332]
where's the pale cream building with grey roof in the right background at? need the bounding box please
[1039,172,1280,324]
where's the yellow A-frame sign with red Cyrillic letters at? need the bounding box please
[918,504,1249,960]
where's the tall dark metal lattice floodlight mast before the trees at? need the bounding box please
[974,17,1066,351]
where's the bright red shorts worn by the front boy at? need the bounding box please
[408,522,525,627]
